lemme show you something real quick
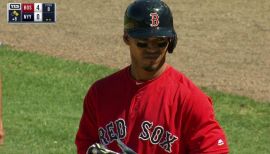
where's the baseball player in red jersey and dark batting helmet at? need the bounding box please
[75,0,229,154]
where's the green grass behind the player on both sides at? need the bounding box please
[0,46,270,154]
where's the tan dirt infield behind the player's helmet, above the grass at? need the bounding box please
[0,0,270,101]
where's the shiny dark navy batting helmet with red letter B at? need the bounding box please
[124,0,177,53]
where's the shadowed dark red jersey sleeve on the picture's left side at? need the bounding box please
[75,87,98,154]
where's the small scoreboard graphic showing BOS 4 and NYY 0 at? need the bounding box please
[7,3,56,23]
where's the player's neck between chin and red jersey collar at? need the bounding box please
[130,63,167,81]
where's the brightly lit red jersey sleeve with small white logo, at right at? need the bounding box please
[184,90,229,154]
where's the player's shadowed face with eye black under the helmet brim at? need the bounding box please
[129,37,169,72]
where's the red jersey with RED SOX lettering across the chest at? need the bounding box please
[75,65,228,154]
